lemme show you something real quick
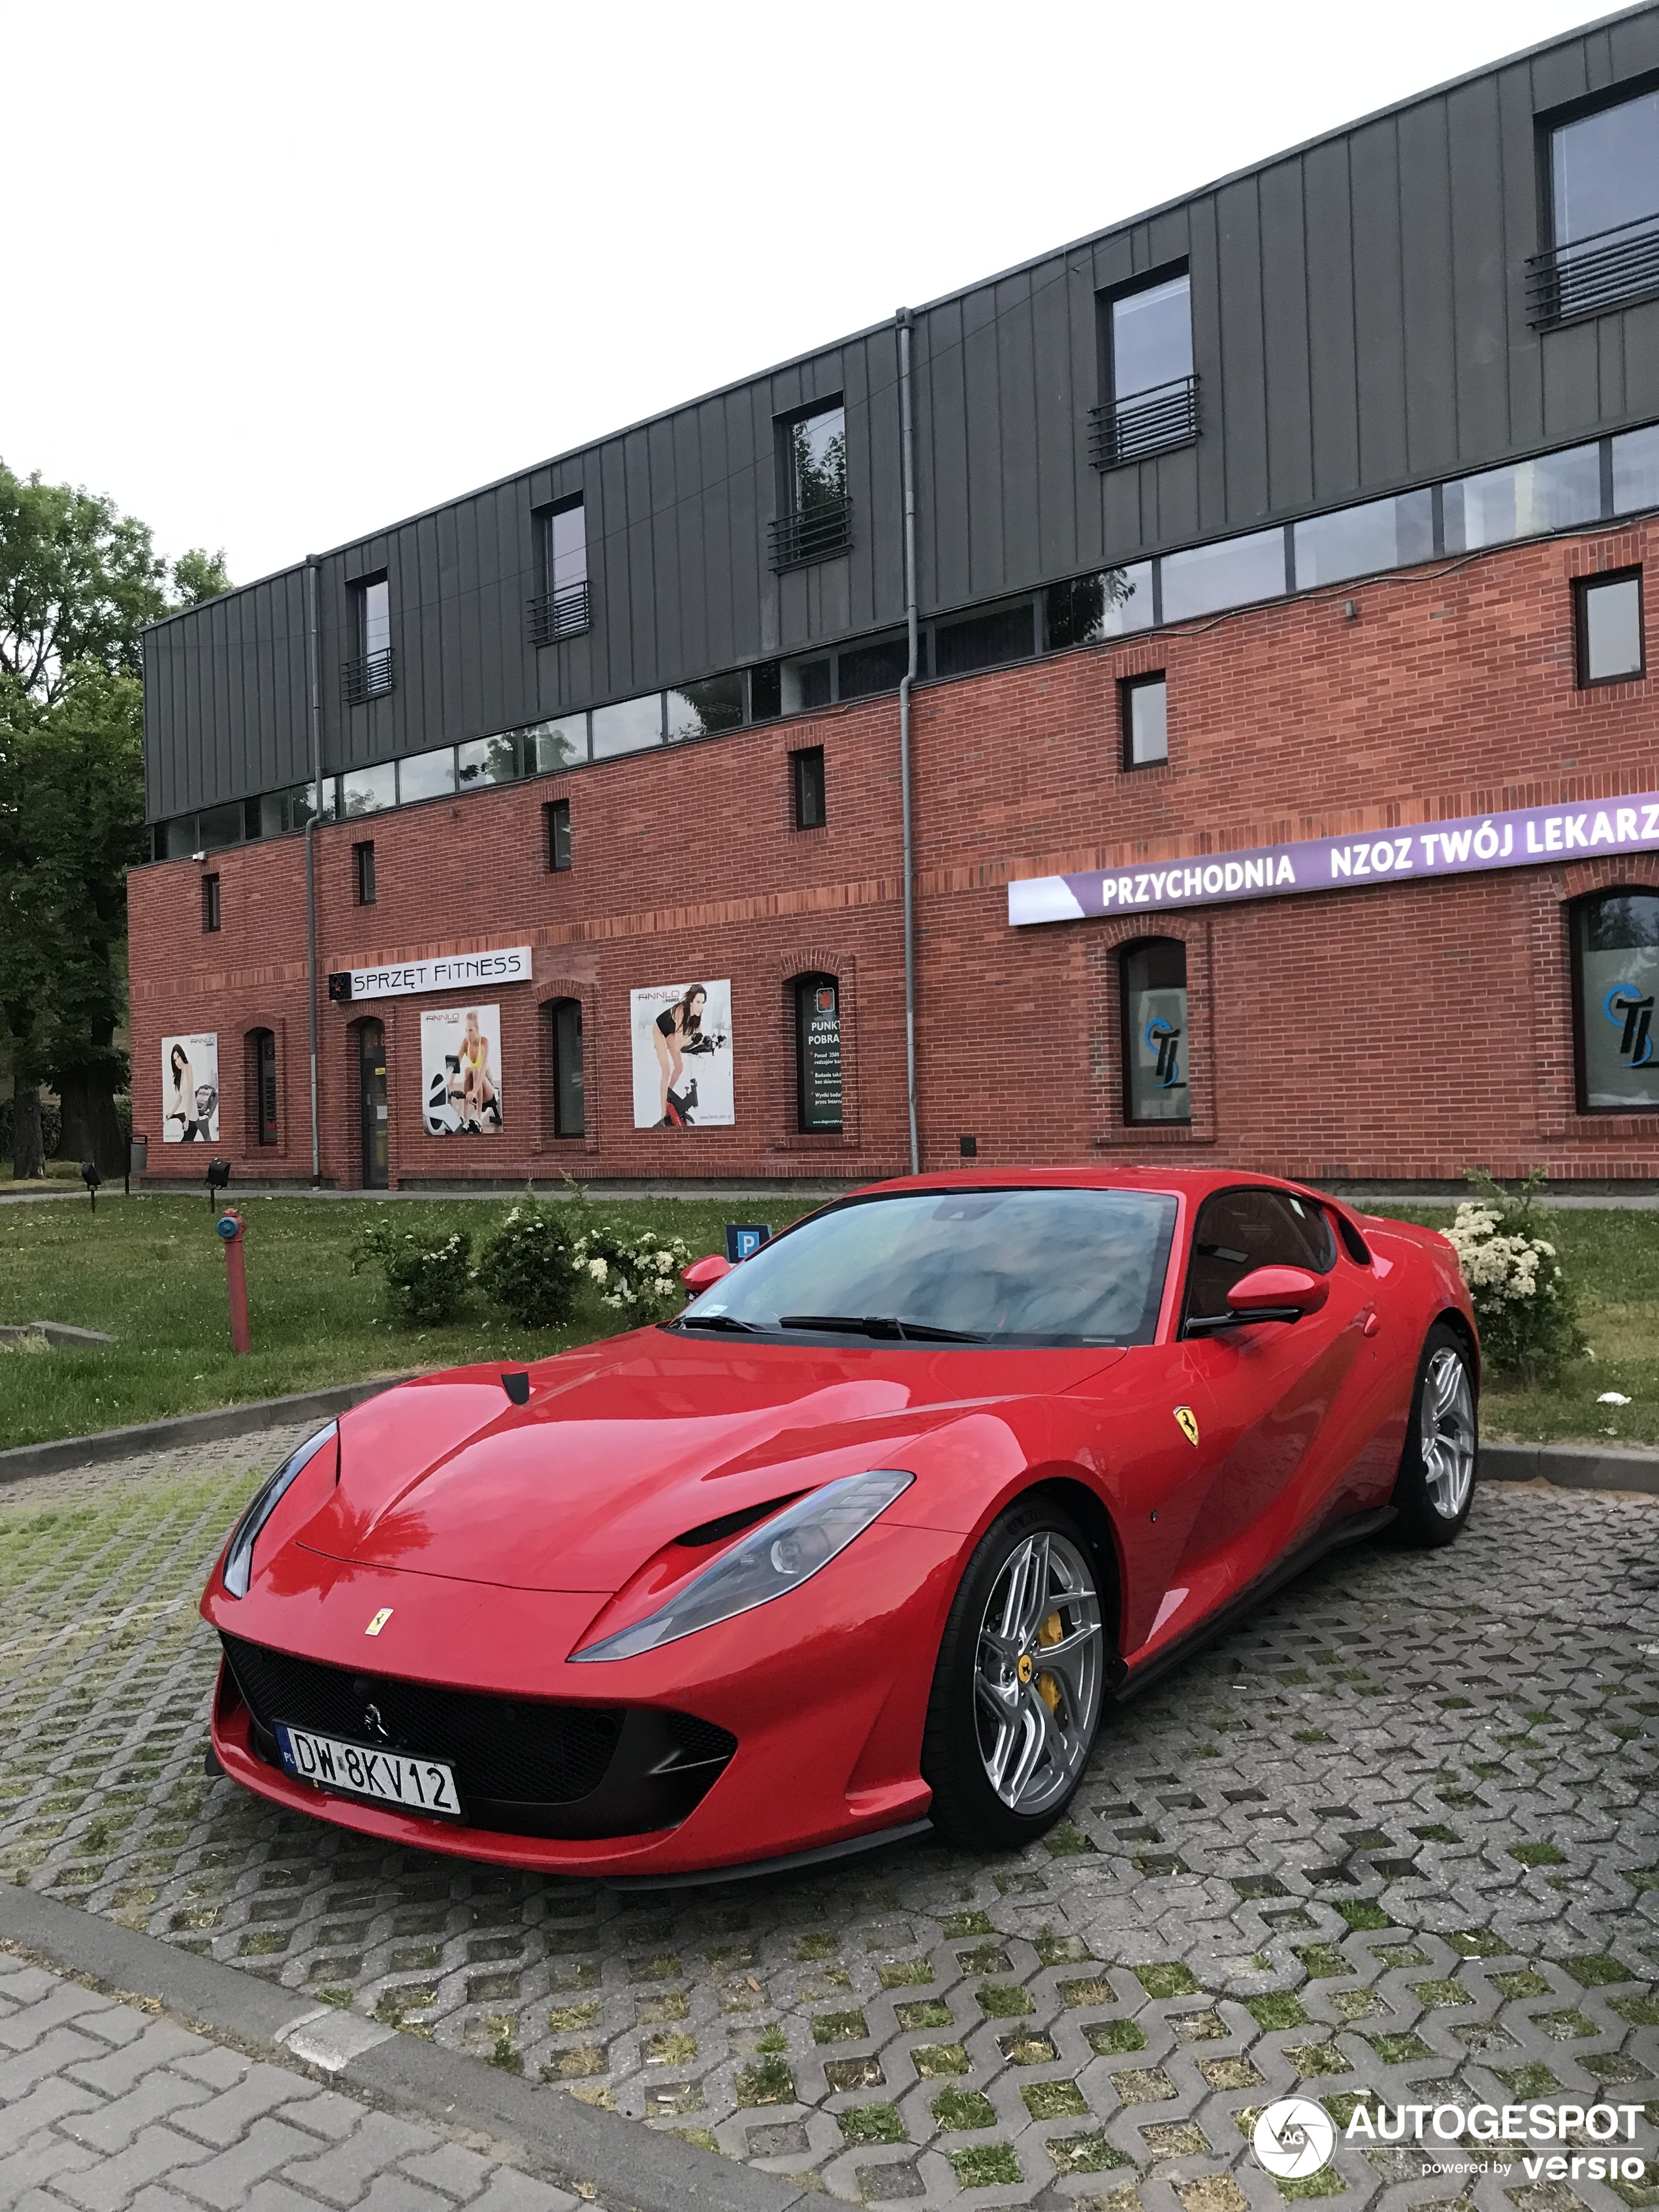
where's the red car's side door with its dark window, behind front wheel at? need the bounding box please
[1181,1185,1374,1577]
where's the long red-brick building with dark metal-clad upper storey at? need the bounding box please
[131,7,1659,1185]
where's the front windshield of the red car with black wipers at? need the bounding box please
[675,1188,1174,1345]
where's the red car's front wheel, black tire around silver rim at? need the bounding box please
[922,1496,1108,1851]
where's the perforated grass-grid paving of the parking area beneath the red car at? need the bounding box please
[0,1431,1659,2212]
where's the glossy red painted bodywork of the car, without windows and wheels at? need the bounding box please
[201,1168,1475,1878]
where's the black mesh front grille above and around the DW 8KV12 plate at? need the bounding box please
[221,1637,628,1805]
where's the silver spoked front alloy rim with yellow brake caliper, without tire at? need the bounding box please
[973,1531,1102,1816]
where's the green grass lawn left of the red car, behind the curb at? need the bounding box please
[0,1196,805,1445]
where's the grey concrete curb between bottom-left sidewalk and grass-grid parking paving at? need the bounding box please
[0,1887,805,2212]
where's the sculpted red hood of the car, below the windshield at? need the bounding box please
[297,1330,1123,1595]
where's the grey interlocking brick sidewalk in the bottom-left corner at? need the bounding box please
[0,1955,579,2212]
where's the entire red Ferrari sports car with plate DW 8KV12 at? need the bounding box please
[201,1168,1480,1880]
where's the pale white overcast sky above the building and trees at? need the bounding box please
[0,0,1628,582]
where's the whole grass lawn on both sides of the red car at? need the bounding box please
[0,1196,1659,1445]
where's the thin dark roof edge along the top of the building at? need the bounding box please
[139,0,1659,635]
